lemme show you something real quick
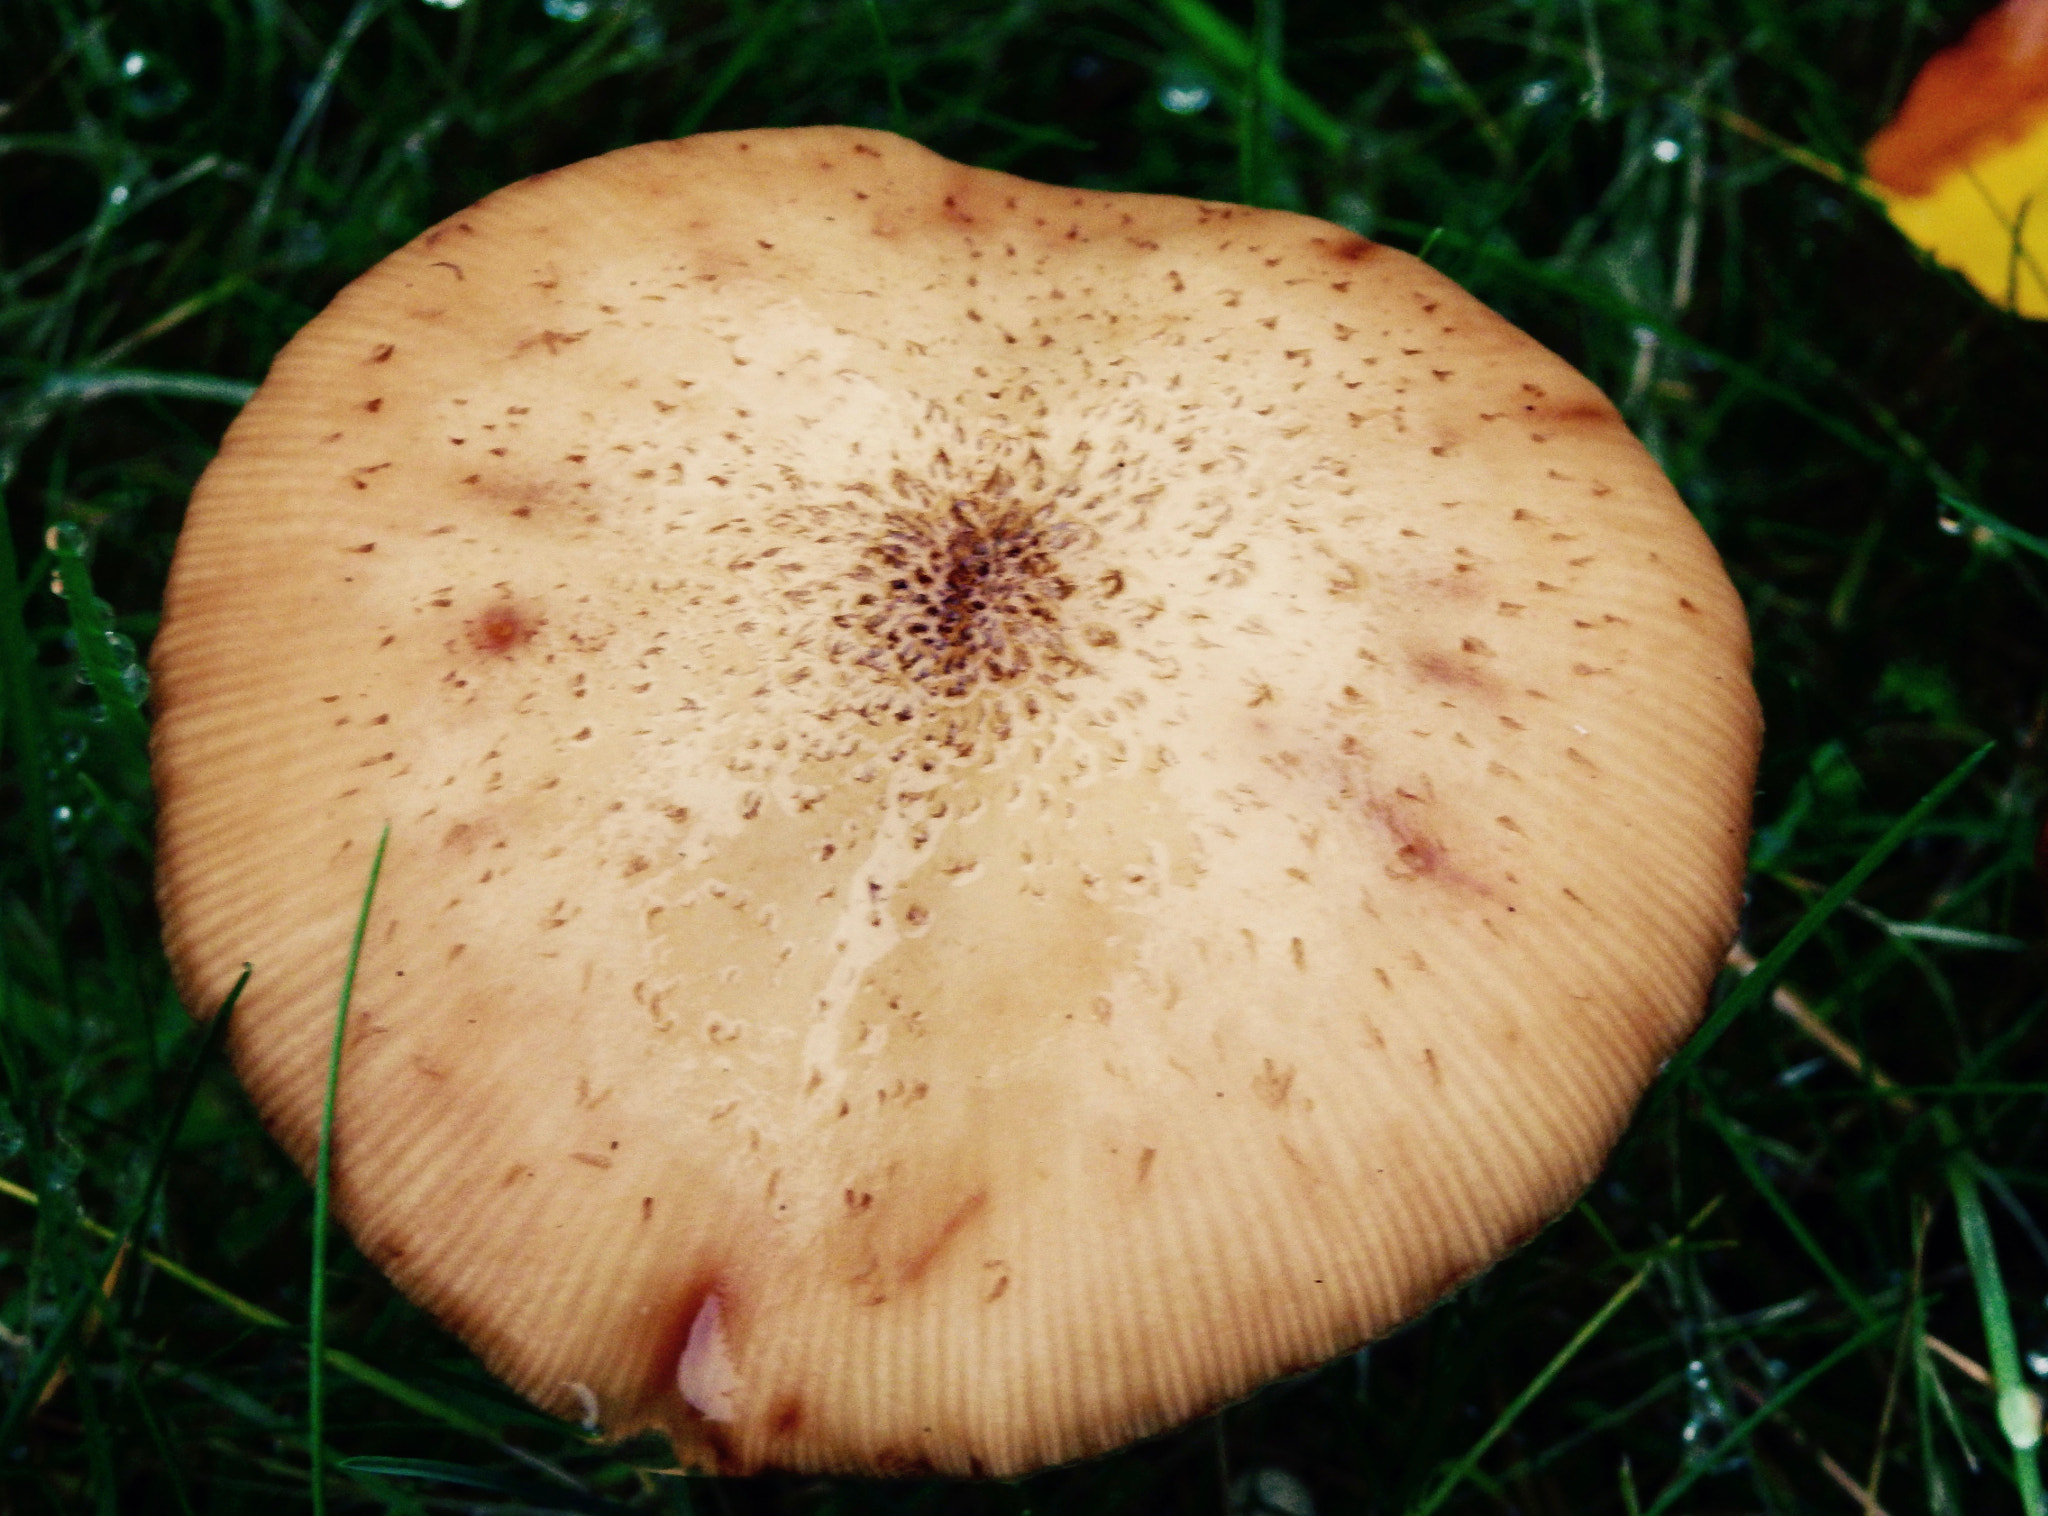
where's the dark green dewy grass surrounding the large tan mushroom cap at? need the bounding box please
[0,0,2048,1516]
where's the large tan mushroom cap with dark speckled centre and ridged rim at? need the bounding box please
[156,129,1757,1473]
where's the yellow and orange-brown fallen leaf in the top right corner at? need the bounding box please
[1866,0,2048,320]
